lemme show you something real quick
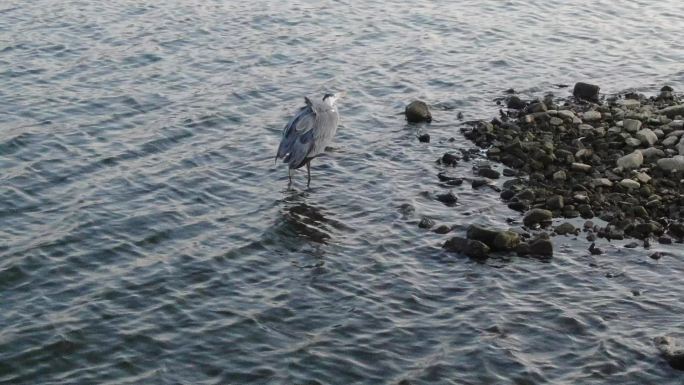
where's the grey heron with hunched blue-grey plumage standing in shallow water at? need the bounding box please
[275,93,342,187]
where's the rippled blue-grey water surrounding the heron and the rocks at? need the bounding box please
[0,0,684,384]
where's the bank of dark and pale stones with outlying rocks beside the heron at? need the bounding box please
[407,83,684,259]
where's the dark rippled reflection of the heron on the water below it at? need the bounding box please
[282,191,335,244]
